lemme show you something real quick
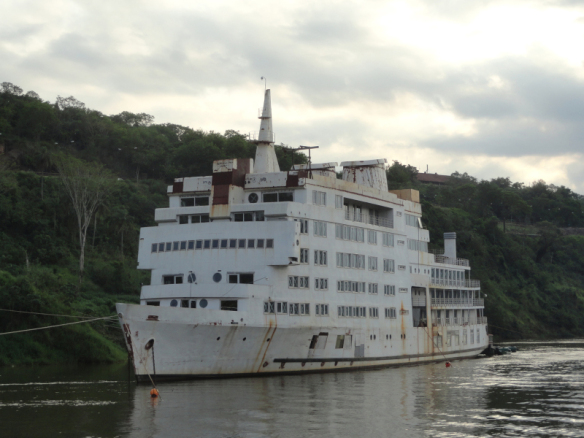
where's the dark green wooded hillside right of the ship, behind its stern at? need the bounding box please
[387,162,584,339]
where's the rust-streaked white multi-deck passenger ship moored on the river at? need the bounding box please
[116,89,489,382]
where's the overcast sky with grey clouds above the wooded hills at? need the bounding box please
[0,0,584,194]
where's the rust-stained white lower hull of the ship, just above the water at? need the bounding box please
[117,304,488,381]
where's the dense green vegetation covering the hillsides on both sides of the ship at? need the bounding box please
[0,83,584,365]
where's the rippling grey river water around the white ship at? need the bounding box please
[0,340,584,438]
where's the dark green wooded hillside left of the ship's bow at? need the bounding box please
[0,82,306,365]
